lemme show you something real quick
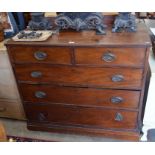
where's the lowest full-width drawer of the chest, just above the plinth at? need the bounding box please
[25,104,137,129]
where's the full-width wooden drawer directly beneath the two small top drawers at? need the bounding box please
[15,64,143,89]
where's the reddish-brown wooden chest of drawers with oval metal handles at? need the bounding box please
[6,24,151,140]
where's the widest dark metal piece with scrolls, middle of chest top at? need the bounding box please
[55,12,106,35]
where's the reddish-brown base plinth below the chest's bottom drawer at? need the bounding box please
[27,121,141,141]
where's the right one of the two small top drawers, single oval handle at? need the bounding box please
[75,48,145,67]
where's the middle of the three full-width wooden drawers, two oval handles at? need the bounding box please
[20,84,140,108]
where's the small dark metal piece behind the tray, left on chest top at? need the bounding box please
[28,12,52,30]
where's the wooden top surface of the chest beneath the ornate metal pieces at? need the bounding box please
[6,23,151,47]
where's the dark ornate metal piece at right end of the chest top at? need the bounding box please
[112,12,136,32]
